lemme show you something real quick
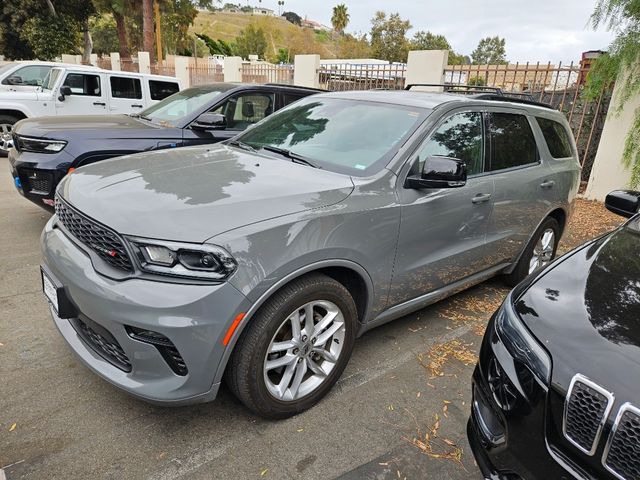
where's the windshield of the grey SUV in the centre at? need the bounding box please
[236,96,429,176]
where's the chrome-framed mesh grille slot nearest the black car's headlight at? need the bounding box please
[563,374,613,455]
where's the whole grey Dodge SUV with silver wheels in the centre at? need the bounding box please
[42,91,580,418]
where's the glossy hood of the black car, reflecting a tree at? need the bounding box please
[515,226,640,402]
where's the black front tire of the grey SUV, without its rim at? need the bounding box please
[225,273,358,419]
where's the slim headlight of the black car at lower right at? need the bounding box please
[495,296,551,385]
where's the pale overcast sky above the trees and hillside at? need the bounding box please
[252,0,613,64]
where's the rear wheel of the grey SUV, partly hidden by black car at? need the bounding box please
[505,217,560,286]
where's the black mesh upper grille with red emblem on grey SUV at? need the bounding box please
[55,197,133,272]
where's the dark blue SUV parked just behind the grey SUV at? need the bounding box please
[9,83,321,210]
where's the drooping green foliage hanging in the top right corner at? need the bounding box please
[584,0,640,188]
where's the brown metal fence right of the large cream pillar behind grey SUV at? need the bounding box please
[445,62,611,181]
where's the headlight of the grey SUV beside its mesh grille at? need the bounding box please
[127,237,238,280]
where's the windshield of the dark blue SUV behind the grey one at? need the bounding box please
[139,87,225,127]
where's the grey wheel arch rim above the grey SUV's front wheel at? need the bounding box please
[214,259,374,384]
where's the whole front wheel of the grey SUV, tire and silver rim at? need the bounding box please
[226,273,358,418]
